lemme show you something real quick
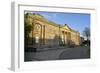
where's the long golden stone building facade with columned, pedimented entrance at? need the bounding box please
[25,13,80,47]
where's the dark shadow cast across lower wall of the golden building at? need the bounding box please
[24,35,76,50]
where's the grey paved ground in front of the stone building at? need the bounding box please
[25,46,89,61]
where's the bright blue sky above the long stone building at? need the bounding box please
[24,12,90,35]
